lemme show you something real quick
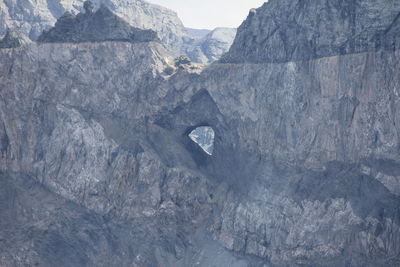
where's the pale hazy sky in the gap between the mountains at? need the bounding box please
[147,0,266,29]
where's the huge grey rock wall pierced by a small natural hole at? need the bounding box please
[0,1,400,267]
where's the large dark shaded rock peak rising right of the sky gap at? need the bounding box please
[221,0,400,63]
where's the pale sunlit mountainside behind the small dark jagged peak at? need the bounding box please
[0,0,186,53]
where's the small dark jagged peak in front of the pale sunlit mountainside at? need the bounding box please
[38,1,159,43]
